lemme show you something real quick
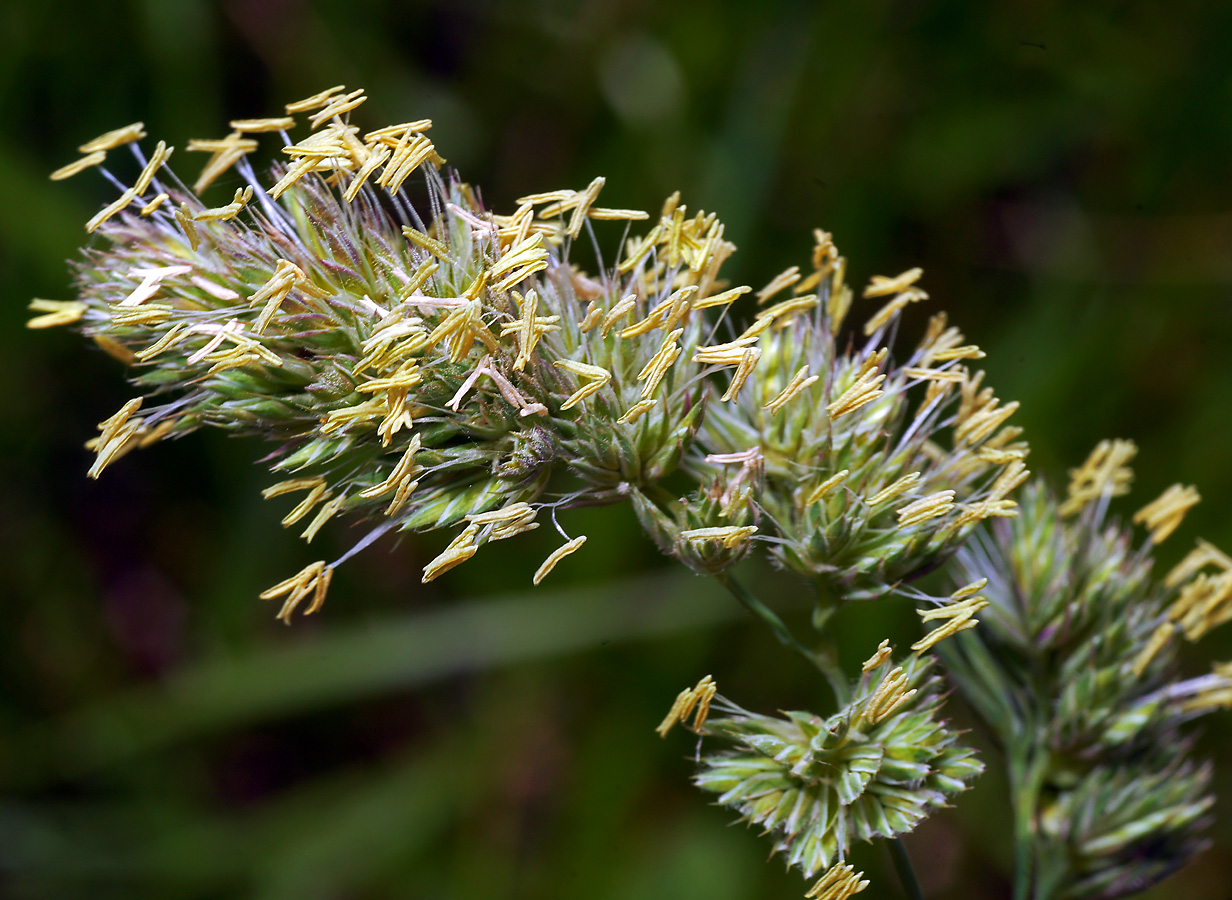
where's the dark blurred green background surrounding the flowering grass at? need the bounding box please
[7,0,1232,900]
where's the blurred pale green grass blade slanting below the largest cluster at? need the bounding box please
[6,571,737,784]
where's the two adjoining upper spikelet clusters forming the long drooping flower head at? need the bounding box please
[30,86,1026,619]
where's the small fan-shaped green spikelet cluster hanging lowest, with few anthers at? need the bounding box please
[660,644,983,877]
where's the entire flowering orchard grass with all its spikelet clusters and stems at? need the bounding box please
[40,85,1232,900]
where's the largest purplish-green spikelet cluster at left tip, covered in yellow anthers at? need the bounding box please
[30,89,740,618]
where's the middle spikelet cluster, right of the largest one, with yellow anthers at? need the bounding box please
[686,242,1027,598]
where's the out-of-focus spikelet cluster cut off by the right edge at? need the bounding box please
[939,441,1232,898]
